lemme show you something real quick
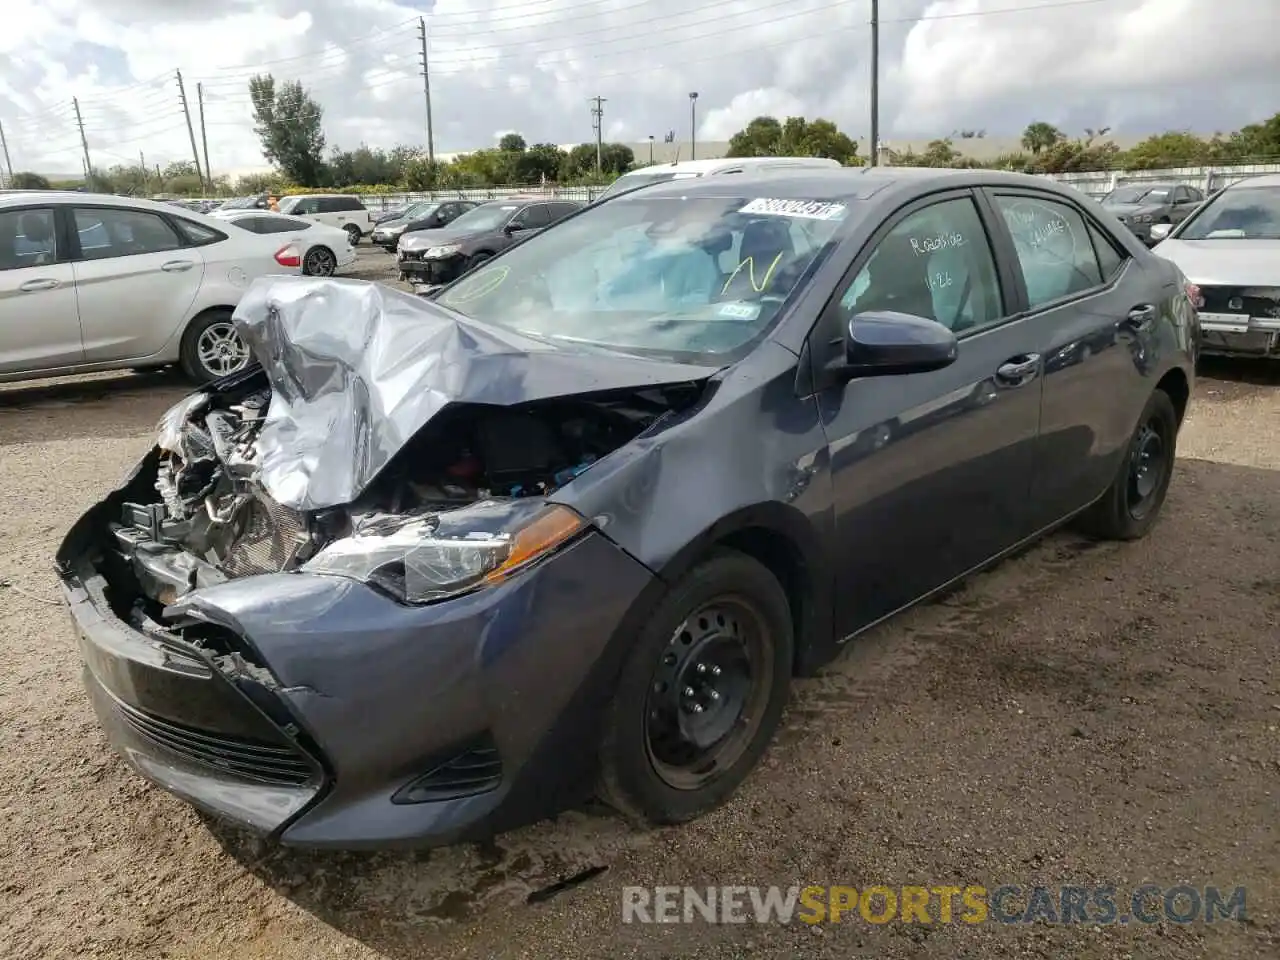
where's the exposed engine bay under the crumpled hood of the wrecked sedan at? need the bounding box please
[110,378,696,613]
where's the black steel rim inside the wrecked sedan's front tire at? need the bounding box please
[645,596,773,790]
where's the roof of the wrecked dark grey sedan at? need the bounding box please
[604,166,1080,204]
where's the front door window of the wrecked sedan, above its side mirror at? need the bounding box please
[840,197,1005,333]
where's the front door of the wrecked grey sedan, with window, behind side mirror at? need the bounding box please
[810,191,1043,636]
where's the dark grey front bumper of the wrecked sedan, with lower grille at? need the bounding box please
[60,504,655,849]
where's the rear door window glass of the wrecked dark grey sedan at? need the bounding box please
[996,195,1102,307]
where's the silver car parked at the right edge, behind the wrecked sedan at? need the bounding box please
[1152,174,1280,358]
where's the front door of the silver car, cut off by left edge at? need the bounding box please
[0,206,84,374]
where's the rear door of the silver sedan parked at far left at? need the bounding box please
[72,206,205,364]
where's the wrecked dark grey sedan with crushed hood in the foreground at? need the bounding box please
[58,168,1197,847]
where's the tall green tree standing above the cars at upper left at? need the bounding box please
[248,73,326,187]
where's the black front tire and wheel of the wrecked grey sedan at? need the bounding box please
[598,550,794,824]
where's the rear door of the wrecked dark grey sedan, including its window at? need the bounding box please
[988,189,1167,527]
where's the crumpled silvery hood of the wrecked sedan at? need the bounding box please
[226,276,716,511]
